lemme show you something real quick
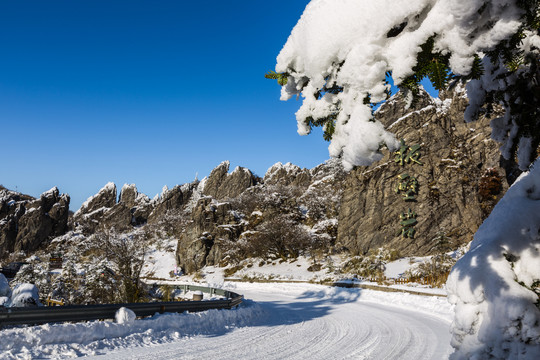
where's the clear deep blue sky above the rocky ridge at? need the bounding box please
[0,0,328,210]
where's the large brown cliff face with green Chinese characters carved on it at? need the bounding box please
[337,89,508,256]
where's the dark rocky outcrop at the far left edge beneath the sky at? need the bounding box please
[0,187,70,257]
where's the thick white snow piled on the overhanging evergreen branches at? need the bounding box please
[276,0,538,169]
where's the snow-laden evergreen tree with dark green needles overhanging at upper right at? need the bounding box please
[272,0,540,169]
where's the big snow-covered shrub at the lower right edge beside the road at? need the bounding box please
[447,161,540,359]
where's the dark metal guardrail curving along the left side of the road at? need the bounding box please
[0,285,244,327]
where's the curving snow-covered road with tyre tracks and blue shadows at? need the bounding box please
[87,284,451,360]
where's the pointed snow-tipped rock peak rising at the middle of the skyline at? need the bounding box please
[203,161,257,200]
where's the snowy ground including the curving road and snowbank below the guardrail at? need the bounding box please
[0,283,452,360]
